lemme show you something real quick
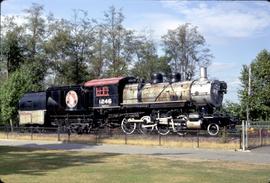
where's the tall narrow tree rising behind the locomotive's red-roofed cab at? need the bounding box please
[102,6,134,76]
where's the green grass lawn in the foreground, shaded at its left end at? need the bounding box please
[0,146,270,183]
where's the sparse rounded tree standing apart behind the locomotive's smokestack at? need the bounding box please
[162,23,212,78]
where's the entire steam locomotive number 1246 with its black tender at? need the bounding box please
[19,67,233,135]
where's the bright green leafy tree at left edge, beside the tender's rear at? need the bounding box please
[0,65,40,123]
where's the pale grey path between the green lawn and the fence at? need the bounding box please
[0,140,270,164]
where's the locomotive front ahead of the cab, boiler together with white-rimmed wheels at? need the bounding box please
[119,68,230,135]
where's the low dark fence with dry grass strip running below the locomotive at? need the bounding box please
[0,126,241,150]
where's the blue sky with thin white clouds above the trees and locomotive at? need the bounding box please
[2,0,270,102]
